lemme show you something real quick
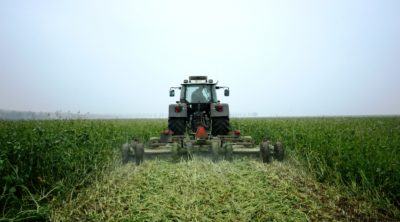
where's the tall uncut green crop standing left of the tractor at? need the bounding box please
[0,120,164,219]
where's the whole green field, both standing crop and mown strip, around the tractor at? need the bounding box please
[0,117,400,221]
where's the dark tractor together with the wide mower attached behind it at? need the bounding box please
[122,76,284,165]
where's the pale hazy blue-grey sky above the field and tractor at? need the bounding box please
[0,0,400,116]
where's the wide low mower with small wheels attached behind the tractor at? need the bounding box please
[124,134,283,164]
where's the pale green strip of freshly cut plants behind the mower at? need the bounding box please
[52,155,382,221]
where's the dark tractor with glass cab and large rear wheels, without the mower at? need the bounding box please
[168,76,231,136]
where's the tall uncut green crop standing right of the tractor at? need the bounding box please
[233,117,400,210]
